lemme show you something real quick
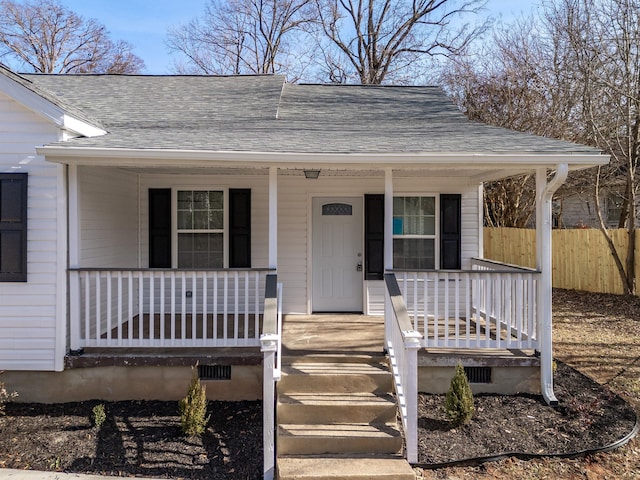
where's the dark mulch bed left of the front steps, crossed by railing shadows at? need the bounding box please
[0,401,263,480]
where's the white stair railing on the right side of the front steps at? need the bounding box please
[384,273,422,463]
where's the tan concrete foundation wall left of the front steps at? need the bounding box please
[1,365,262,403]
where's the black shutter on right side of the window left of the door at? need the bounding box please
[229,188,251,268]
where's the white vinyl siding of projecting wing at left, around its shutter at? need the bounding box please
[0,94,65,370]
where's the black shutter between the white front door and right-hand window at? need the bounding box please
[364,195,384,280]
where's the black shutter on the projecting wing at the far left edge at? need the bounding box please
[0,173,28,282]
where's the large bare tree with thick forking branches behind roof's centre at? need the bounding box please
[314,0,485,84]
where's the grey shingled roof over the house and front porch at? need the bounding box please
[22,74,600,155]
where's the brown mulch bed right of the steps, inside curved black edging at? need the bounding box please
[418,362,635,464]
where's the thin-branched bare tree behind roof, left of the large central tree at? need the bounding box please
[168,0,310,78]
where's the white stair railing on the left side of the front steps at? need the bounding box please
[260,274,282,480]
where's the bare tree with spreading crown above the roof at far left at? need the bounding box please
[0,0,144,73]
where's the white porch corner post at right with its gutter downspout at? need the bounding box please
[536,163,569,406]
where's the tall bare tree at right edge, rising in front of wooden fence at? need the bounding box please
[549,0,640,294]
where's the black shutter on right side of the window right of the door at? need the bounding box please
[440,194,462,270]
